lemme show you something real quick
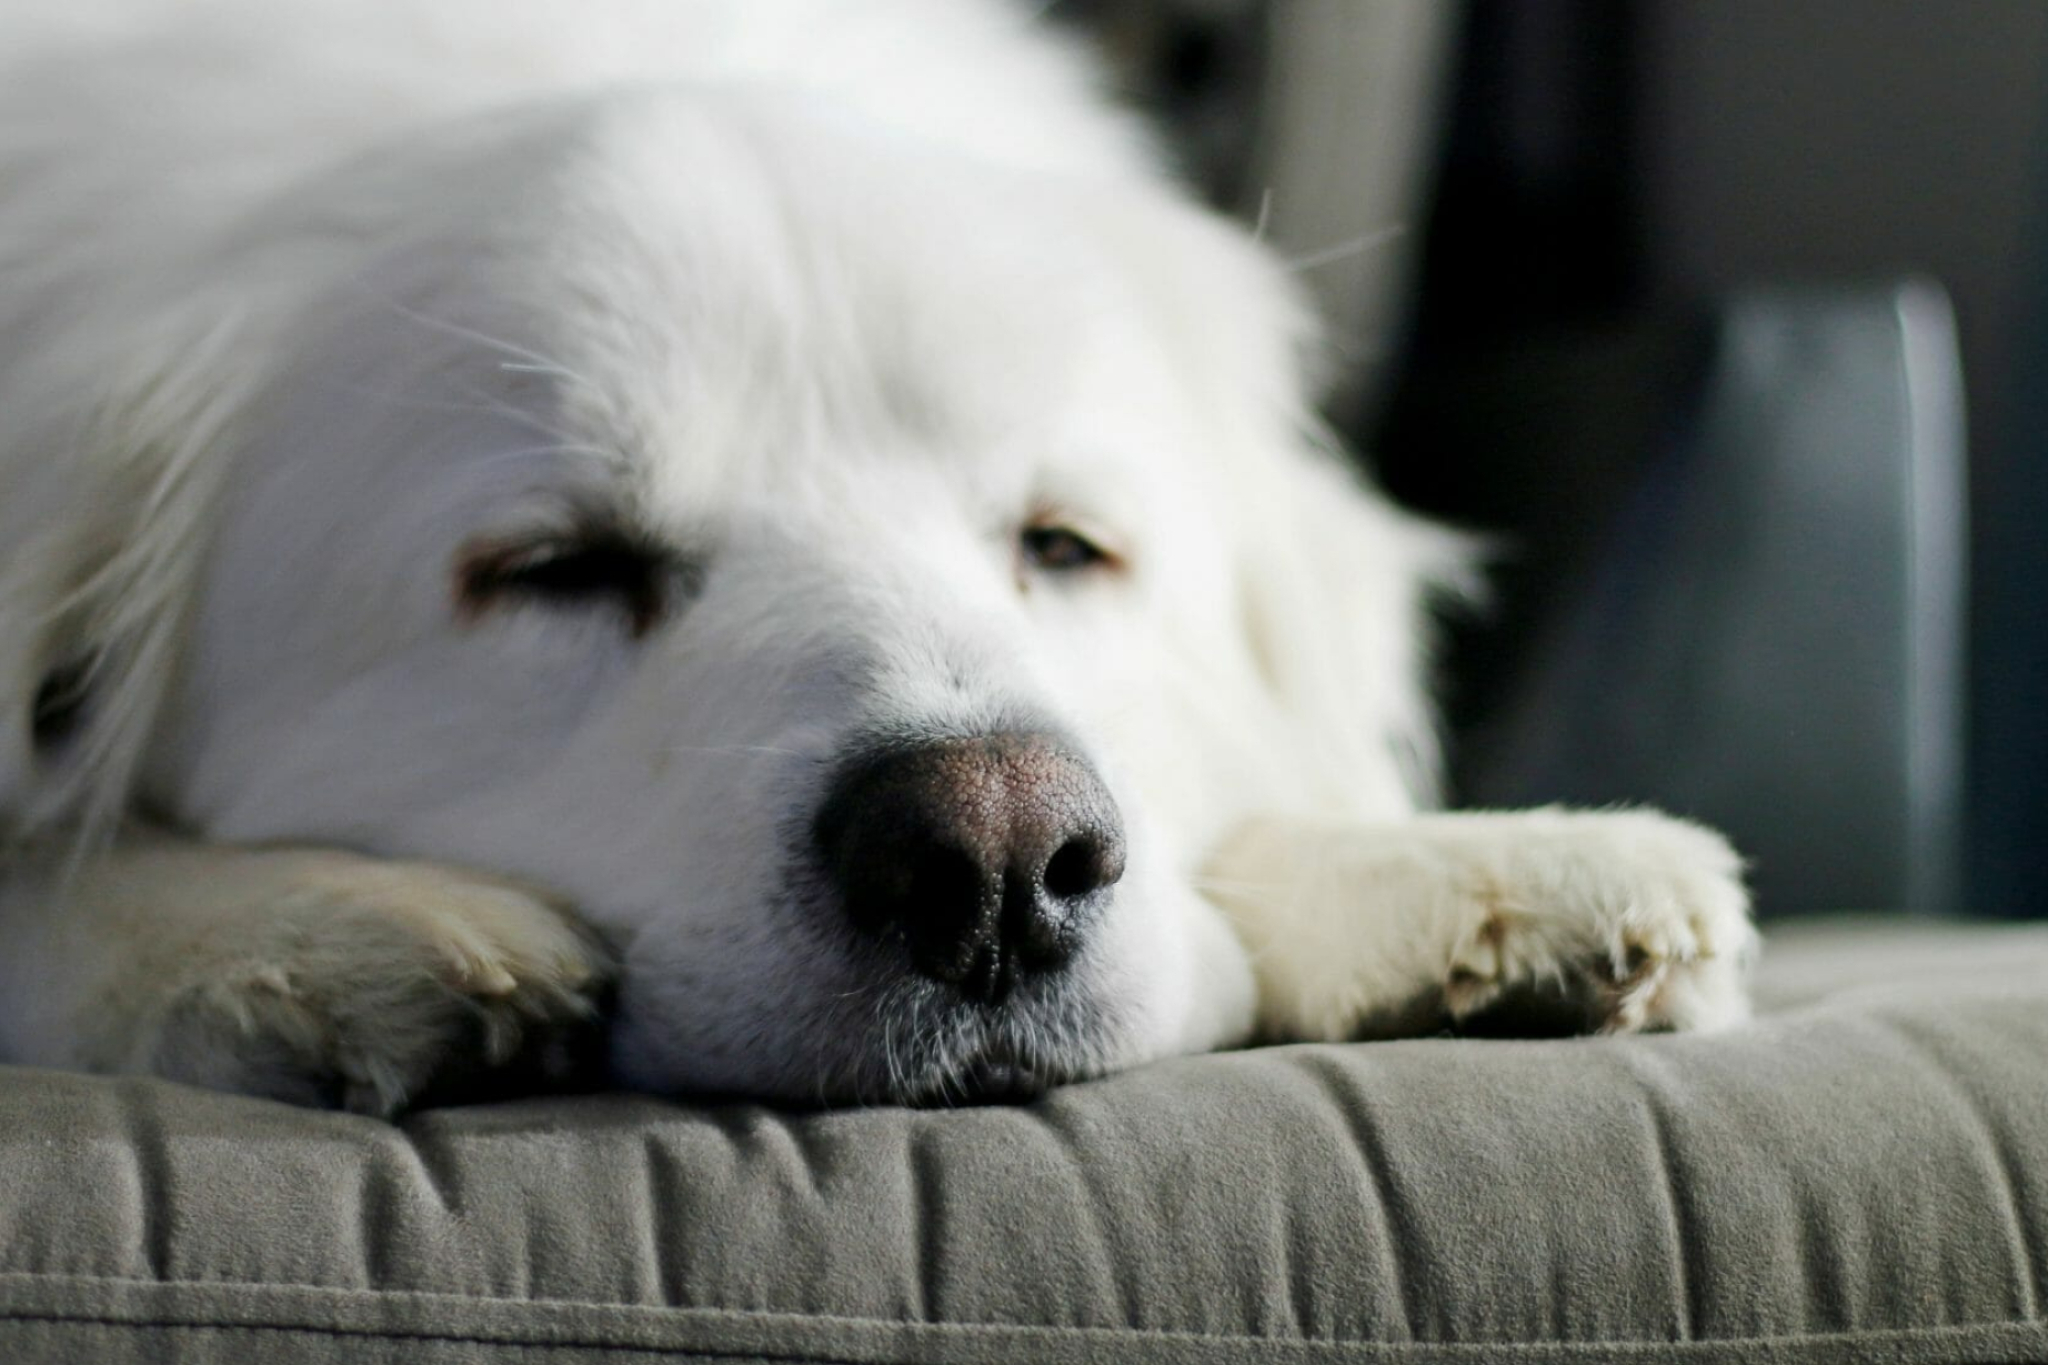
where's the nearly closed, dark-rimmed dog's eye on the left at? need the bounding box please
[457,534,676,634]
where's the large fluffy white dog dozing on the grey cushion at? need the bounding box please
[0,0,1755,1113]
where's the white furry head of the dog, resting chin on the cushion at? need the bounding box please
[8,92,1444,1099]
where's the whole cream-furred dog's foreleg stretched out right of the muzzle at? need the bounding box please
[1206,808,1757,1040]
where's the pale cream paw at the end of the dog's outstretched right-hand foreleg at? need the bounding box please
[1442,810,1757,1033]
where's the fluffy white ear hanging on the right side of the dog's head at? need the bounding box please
[1243,440,1479,819]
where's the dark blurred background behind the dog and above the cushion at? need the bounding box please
[1049,0,2048,917]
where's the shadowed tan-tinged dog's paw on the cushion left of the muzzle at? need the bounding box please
[135,853,610,1115]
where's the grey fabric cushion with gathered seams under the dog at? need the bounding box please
[0,912,2048,1361]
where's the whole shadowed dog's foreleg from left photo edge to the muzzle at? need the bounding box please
[0,829,606,1113]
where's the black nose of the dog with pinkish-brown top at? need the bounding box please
[815,735,1124,1005]
